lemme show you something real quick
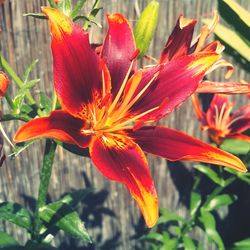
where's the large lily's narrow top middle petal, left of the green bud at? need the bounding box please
[101,13,135,97]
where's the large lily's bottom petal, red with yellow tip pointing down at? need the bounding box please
[90,135,158,227]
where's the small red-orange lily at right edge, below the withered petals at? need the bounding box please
[192,94,250,145]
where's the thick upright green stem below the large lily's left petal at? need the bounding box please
[32,139,56,240]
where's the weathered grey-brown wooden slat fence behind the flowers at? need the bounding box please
[0,0,250,250]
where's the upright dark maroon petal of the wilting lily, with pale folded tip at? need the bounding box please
[159,15,196,63]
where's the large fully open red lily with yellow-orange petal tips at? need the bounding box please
[14,7,246,227]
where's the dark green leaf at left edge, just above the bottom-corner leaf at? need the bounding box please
[0,202,31,230]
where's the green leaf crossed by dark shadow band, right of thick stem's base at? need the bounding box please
[39,201,91,242]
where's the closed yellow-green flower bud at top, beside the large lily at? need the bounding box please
[134,0,159,56]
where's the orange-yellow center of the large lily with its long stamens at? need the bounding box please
[83,56,160,134]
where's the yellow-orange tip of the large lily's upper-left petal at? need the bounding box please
[41,7,73,40]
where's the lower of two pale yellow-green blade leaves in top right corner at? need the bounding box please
[202,19,250,62]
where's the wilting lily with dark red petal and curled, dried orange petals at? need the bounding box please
[159,12,250,94]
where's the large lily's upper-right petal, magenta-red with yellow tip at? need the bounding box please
[131,53,219,120]
